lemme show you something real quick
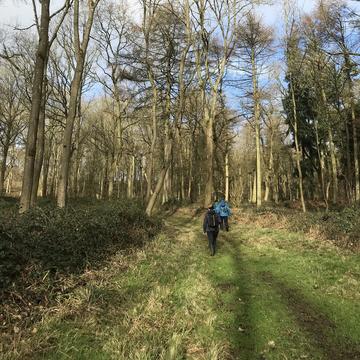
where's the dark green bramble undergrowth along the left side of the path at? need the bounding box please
[0,201,161,351]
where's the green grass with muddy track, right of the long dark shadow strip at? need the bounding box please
[215,227,360,359]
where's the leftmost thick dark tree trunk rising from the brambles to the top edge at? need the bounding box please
[19,0,50,213]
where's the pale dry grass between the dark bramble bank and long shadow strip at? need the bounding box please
[2,215,229,360]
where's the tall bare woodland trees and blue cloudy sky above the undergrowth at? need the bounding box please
[0,1,360,214]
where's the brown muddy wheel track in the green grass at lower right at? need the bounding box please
[260,272,360,360]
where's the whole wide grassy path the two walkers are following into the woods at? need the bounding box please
[5,212,360,360]
